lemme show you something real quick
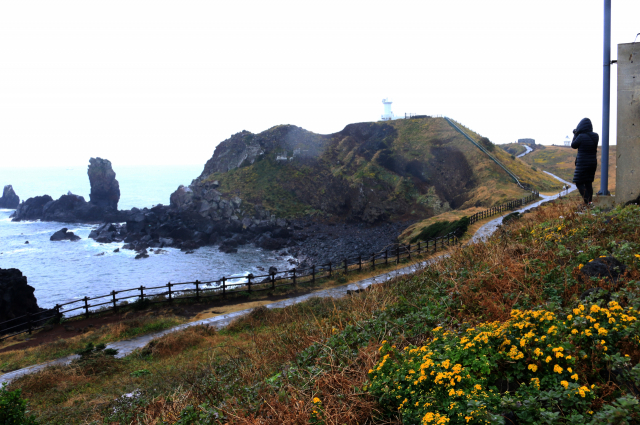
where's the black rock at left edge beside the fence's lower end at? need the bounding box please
[0,269,42,331]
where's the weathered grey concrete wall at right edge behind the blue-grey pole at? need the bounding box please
[616,43,640,203]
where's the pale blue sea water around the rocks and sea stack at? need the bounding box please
[0,165,291,307]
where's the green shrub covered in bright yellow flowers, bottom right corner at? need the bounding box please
[369,301,640,424]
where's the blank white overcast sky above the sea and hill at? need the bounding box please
[0,0,640,169]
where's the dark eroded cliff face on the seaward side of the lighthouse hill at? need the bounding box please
[190,117,475,223]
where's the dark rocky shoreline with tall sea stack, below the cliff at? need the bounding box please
[3,158,410,267]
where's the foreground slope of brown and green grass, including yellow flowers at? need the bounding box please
[11,193,640,424]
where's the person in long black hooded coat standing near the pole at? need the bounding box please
[571,118,600,204]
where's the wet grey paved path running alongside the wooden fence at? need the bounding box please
[0,171,576,384]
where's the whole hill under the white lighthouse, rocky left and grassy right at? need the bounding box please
[195,117,560,223]
